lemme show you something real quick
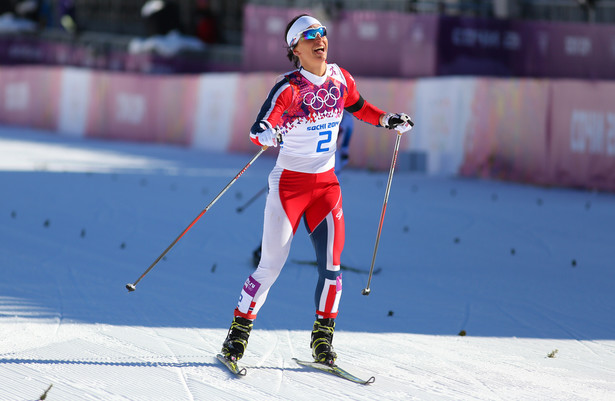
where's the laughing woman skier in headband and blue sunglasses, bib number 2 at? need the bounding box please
[222,14,413,365]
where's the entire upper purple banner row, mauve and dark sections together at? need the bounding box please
[243,5,615,79]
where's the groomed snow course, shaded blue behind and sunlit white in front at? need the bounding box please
[0,127,615,401]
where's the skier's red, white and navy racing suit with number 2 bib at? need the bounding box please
[235,64,383,319]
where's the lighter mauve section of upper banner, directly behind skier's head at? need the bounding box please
[243,4,438,77]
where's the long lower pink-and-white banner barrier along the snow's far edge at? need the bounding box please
[0,66,615,191]
